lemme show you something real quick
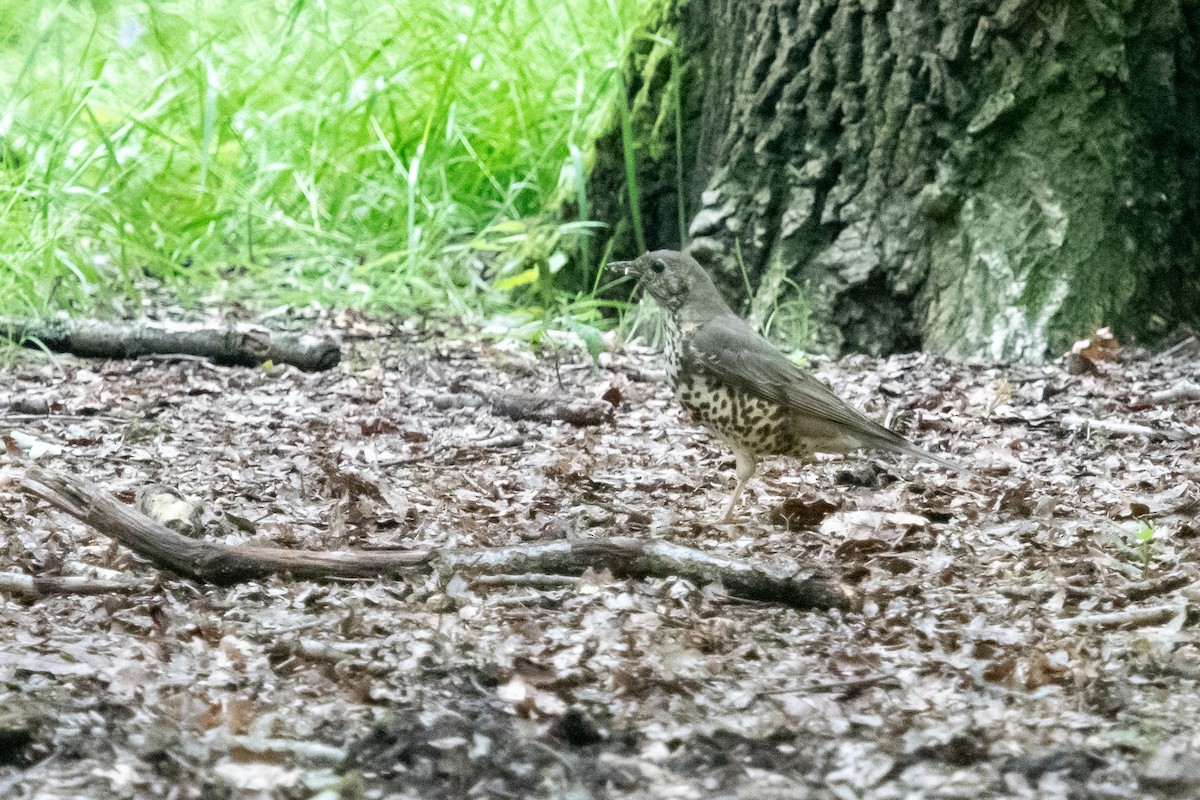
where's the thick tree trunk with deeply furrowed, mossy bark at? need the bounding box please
[592,0,1200,360]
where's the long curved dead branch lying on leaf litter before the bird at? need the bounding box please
[22,468,857,609]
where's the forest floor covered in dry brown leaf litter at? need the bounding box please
[0,320,1200,800]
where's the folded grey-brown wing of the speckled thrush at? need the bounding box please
[683,313,912,451]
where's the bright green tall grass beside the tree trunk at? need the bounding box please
[0,0,641,319]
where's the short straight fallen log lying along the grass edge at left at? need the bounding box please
[0,319,342,372]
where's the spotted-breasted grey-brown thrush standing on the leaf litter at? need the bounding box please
[608,249,964,522]
